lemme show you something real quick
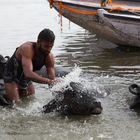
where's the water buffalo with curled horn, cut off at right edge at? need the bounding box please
[129,84,140,110]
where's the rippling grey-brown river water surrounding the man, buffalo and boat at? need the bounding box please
[0,0,140,140]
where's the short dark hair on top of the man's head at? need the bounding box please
[38,29,55,42]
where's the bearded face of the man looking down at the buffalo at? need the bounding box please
[38,40,54,54]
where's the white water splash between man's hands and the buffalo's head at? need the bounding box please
[50,65,110,98]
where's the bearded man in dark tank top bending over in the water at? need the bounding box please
[4,29,55,103]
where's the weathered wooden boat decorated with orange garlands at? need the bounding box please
[49,0,140,47]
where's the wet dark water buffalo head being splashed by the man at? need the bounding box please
[43,82,102,115]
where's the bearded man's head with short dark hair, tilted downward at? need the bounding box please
[37,29,55,54]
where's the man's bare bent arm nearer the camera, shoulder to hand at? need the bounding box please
[21,46,54,84]
